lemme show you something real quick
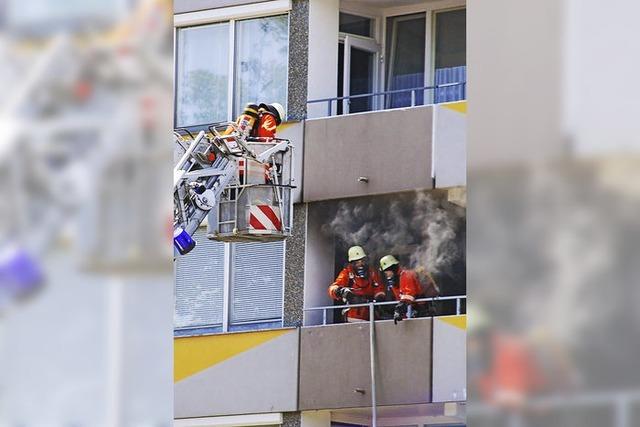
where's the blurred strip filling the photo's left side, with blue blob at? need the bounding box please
[0,0,173,426]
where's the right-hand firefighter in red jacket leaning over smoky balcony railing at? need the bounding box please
[380,255,422,324]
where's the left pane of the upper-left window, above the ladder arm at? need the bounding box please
[176,23,229,127]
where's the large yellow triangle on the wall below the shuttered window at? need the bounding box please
[173,329,295,382]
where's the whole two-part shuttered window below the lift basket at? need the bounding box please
[174,229,284,334]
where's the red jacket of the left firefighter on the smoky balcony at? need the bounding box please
[329,264,384,321]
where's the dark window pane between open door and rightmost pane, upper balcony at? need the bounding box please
[386,13,426,108]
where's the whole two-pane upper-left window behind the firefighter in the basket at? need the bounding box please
[175,15,289,127]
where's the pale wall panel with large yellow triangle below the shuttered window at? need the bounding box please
[174,329,299,418]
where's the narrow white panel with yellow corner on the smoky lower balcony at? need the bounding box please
[433,315,467,402]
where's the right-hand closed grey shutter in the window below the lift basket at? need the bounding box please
[230,242,284,324]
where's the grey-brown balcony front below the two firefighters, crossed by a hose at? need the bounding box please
[299,319,431,410]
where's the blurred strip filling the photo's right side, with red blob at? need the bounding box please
[467,0,640,427]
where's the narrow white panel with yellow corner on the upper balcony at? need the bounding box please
[433,101,467,188]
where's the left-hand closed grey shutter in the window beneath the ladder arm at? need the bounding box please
[174,228,224,328]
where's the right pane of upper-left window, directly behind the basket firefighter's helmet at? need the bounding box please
[234,15,289,116]
